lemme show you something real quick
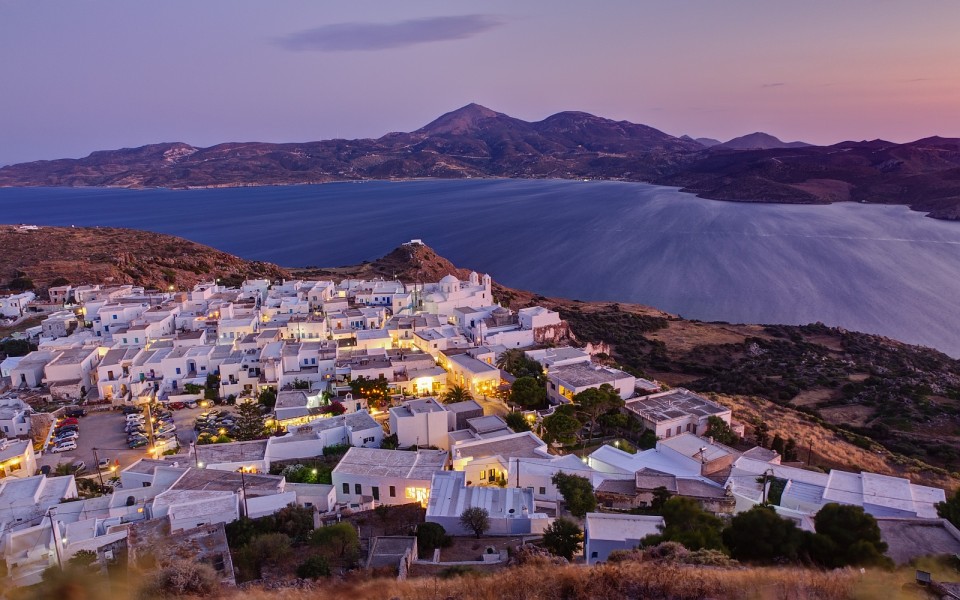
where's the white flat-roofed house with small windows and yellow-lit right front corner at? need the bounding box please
[332,448,447,505]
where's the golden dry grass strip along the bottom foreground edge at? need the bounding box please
[231,563,859,600]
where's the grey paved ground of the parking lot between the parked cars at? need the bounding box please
[37,408,209,474]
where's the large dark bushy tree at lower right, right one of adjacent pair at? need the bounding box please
[808,503,893,568]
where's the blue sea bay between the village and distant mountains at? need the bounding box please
[0,180,960,356]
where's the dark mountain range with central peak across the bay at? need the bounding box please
[0,104,960,219]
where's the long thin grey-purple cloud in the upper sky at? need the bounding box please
[276,15,504,52]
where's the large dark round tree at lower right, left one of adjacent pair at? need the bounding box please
[723,506,803,564]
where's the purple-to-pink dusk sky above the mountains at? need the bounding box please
[0,0,960,165]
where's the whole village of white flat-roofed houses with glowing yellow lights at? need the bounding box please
[0,240,960,586]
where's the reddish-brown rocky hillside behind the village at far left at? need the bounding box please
[0,225,288,290]
